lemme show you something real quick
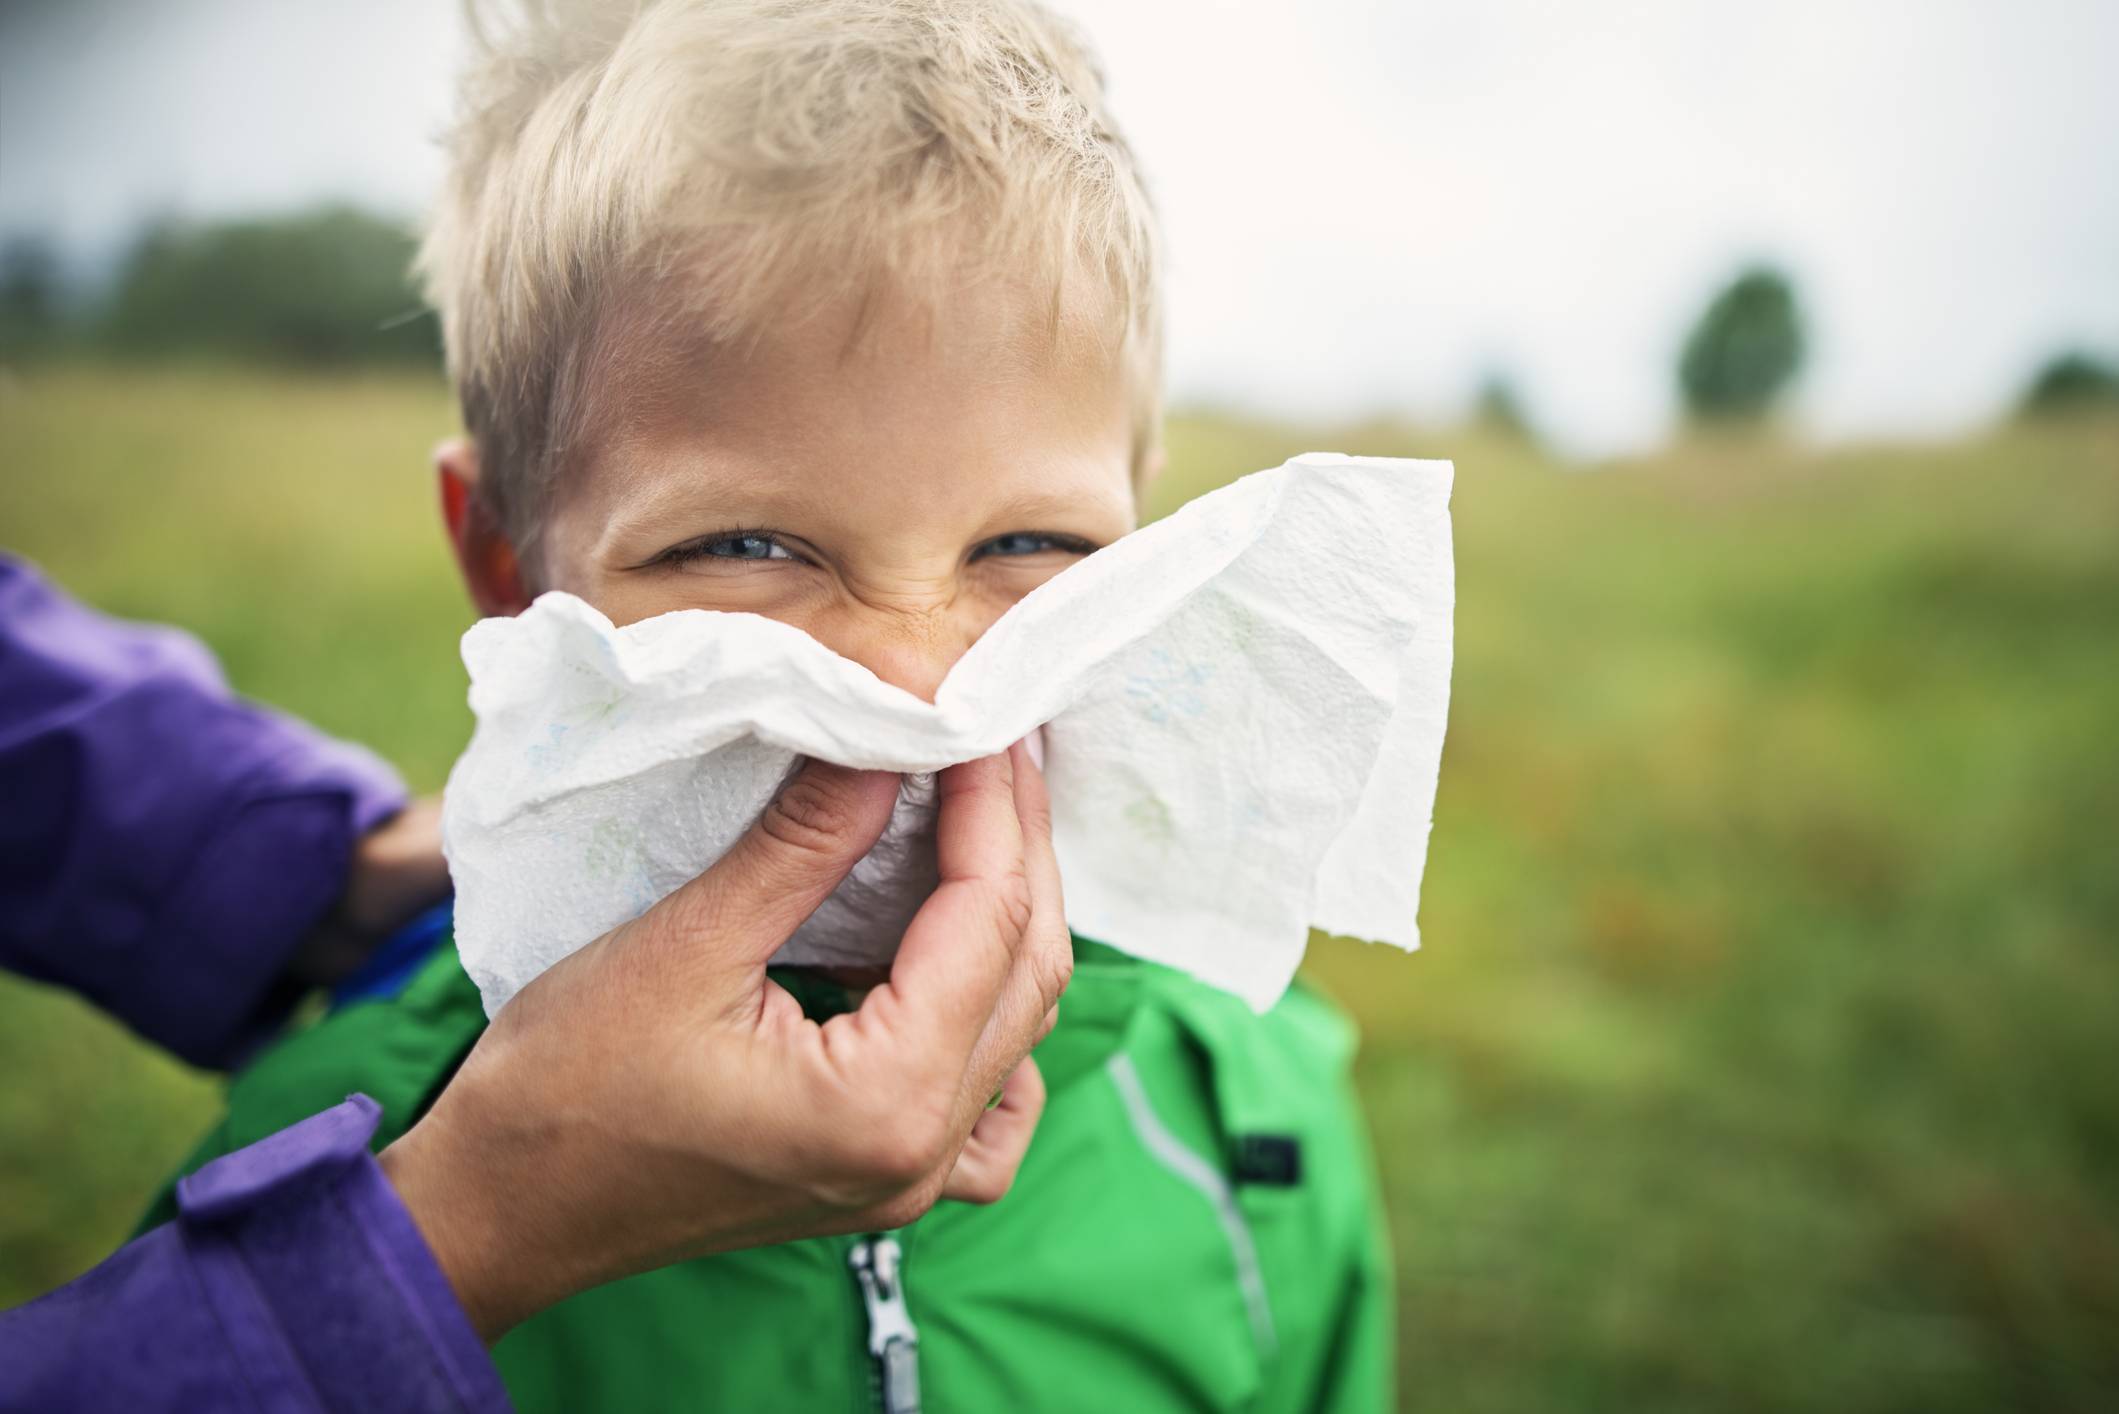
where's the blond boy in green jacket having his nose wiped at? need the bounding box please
[161,0,1390,1412]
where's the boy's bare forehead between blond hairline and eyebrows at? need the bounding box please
[559,268,1132,546]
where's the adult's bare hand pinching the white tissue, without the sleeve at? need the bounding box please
[381,744,1072,1340]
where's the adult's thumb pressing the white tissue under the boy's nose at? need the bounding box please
[642,761,898,969]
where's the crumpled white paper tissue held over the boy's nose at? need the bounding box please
[443,454,1454,1013]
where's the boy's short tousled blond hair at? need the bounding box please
[420,0,1161,553]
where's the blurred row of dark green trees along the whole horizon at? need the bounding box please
[0,206,2119,437]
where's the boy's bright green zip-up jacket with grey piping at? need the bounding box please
[163,939,1392,1414]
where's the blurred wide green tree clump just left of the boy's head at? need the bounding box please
[102,206,441,367]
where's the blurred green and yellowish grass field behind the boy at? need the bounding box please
[0,371,2119,1412]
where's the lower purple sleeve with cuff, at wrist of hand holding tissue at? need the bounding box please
[0,1096,509,1414]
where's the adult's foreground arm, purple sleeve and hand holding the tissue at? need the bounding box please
[0,744,1072,1414]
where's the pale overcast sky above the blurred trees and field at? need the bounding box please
[0,0,2119,452]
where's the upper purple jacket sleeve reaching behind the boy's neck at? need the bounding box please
[0,555,405,1066]
